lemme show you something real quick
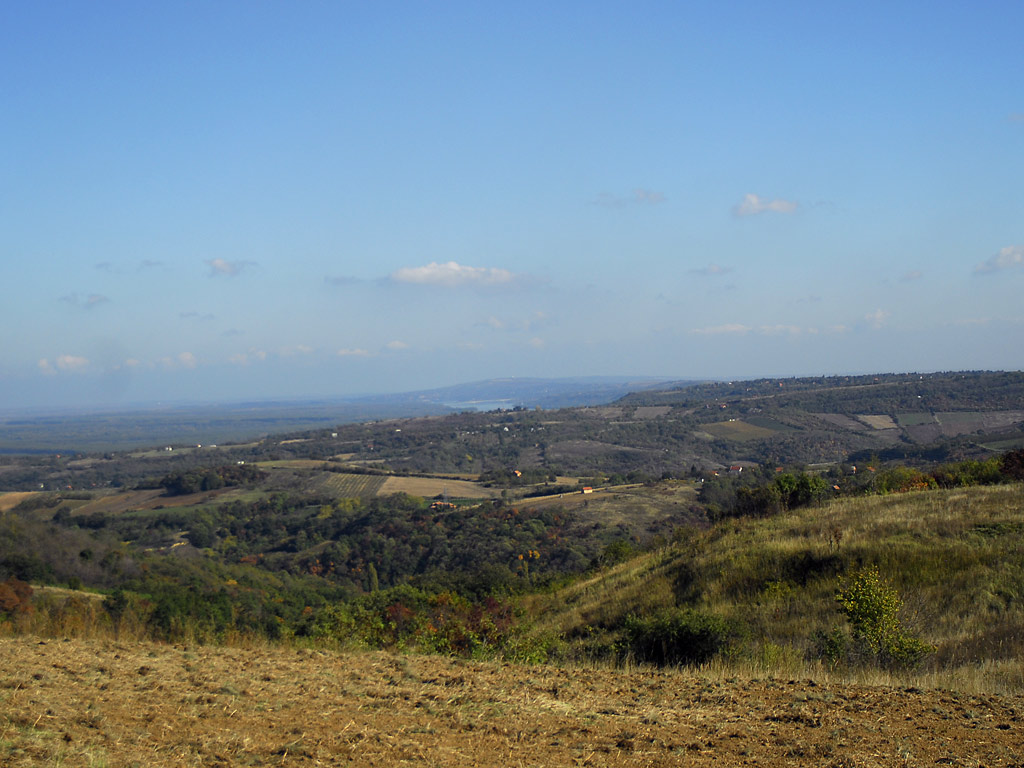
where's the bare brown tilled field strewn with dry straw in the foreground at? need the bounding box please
[0,637,1024,768]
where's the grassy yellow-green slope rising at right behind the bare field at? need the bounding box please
[529,485,1024,690]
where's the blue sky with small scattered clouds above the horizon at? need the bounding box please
[0,0,1024,408]
